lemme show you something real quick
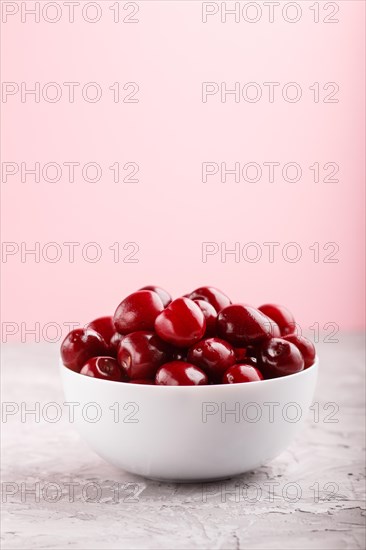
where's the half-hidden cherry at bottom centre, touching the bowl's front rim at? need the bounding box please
[155,361,208,386]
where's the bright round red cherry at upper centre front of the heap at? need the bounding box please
[155,298,206,347]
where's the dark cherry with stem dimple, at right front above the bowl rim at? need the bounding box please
[258,338,304,378]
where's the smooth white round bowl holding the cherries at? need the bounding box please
[61,359,318,482]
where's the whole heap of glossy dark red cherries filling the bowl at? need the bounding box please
[61,286,315,386]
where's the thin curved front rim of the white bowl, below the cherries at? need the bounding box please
[59,355,319,391]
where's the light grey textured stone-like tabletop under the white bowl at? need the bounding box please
[2,335,365,550]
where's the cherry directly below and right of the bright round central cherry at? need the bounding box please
[187,338,236,382]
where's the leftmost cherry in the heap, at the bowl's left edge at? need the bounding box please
[61,328,108,372]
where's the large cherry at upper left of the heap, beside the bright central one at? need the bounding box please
[113,290,164,334]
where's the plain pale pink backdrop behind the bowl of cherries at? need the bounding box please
[1,1,365,339]
